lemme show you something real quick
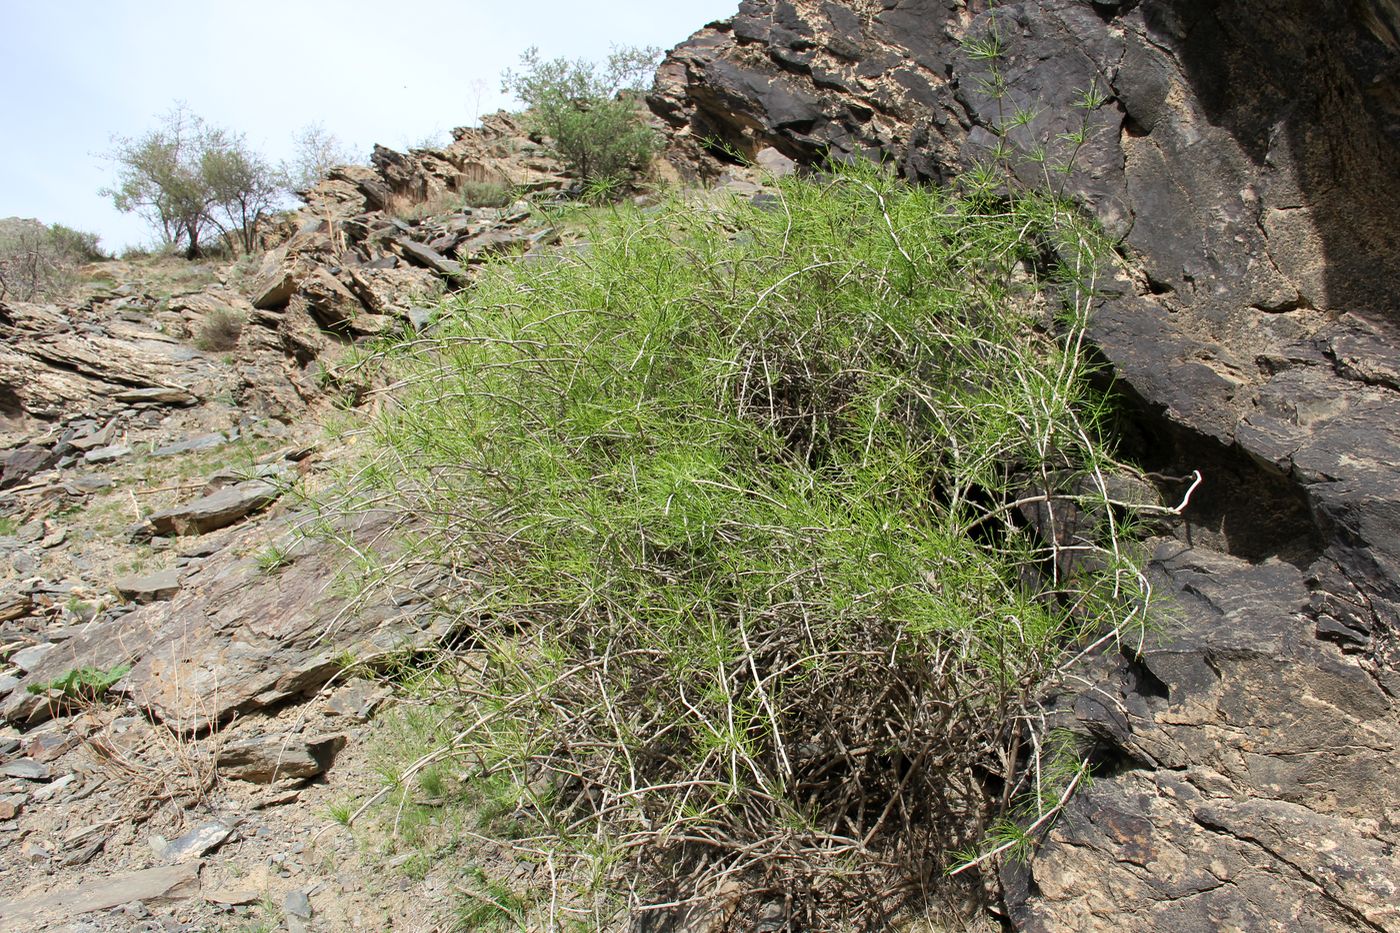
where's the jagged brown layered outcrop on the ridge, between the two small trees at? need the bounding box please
[229,113,567,420]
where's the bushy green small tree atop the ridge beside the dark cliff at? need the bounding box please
[501,46,661,184]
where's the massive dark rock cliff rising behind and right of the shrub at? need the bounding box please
[651,0,1400,930]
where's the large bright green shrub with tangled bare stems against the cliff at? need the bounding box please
[333,168,1147,929]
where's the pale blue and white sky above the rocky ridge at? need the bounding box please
[0,0,738,251]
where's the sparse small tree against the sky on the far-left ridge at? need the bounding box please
[102,104,283,259]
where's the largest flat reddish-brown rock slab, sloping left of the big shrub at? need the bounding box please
[0,513,449,731]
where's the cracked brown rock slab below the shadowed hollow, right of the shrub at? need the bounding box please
[1005,542,1400,930]
